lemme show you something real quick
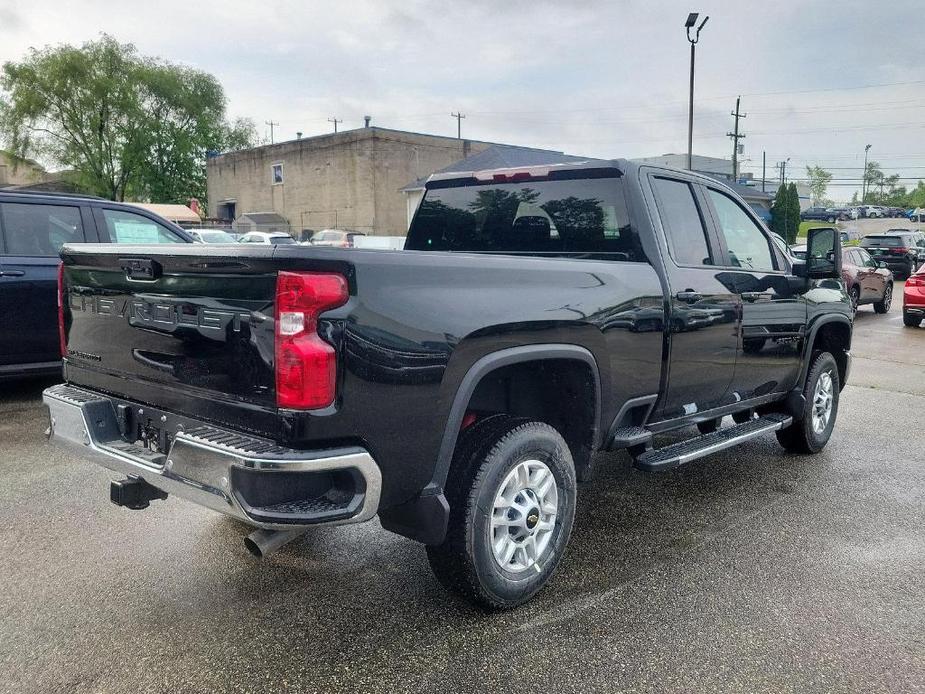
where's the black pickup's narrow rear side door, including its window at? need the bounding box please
[649,175,741,419]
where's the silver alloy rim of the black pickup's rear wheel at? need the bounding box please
[488,460,559,573]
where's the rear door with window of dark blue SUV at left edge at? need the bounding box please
[0,201,95,366]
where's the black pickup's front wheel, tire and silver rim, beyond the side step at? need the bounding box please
[777,352,840,453]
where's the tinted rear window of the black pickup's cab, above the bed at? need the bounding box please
[405,177,645,262]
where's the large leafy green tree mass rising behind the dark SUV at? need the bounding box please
[0,35,254,202]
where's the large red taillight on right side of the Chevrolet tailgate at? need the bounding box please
[276,272,349,410]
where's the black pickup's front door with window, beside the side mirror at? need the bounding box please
[706,186,807,401]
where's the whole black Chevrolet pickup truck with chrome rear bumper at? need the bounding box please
[44,160,853,608]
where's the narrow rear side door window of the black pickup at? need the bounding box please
[652,178,713,265]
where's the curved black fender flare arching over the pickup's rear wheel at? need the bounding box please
[424,344,601,494]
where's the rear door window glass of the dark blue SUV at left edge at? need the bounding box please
[0,202,86,258]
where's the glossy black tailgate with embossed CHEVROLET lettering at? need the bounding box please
[62,245,342,434]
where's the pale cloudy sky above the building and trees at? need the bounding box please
[0,0,925,199]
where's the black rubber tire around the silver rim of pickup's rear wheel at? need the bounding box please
[427,415,576,610]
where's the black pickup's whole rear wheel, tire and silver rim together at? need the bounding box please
[427,415,576,609]
